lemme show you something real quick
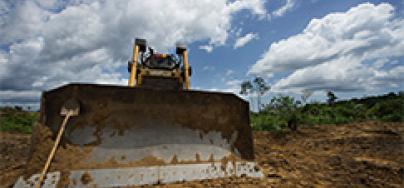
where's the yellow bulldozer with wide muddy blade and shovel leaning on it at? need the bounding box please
[14,39,263,188]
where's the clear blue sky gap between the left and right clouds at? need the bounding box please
[190,0,404,101]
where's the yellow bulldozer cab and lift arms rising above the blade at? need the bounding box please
[128,39,191,90]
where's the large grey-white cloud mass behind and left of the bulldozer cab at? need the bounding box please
[0,0,266,106]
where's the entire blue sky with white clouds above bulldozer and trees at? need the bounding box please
[0,0,404,106]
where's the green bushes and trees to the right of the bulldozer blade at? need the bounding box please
[251,92,404,131]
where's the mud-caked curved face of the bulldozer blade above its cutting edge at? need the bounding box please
[40,84,254,168]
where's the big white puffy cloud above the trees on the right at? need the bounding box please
[249,3,404,91]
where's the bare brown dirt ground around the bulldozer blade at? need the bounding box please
[0,122,404,187]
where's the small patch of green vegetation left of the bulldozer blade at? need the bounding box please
[0,106,38,133]
